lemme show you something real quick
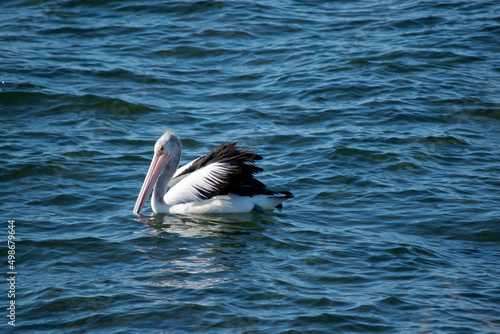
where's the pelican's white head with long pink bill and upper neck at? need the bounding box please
[134,131,182,214]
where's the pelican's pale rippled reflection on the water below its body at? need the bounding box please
[132,213,266,289]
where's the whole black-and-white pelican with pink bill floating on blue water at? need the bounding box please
[134,131,293,215]
